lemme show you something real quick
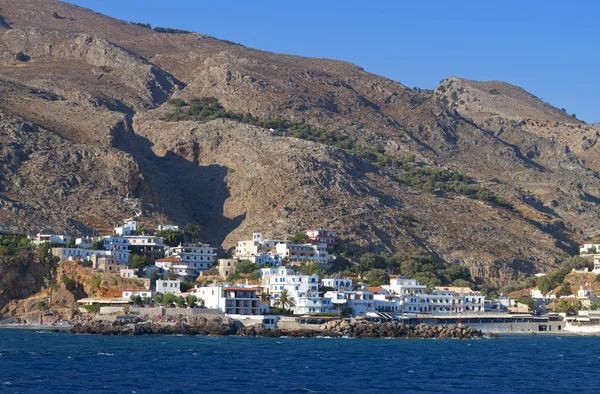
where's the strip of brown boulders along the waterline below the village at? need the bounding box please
[70,316,483,339]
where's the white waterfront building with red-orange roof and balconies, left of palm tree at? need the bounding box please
[192,286,261,315]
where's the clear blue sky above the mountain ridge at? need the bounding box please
[68,0,600,122]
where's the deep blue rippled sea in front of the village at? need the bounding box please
[0,329,600,394]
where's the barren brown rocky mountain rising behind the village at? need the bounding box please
[0,0,600,282]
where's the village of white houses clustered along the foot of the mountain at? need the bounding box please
[7,220,600,332]
